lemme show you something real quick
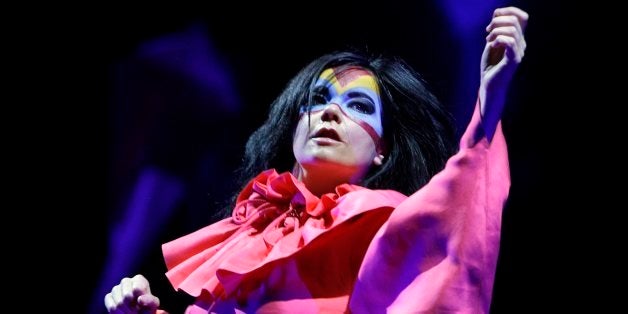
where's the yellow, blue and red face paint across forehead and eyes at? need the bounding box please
[301,67,384,143]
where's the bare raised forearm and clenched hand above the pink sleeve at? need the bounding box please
[479,7,528,141]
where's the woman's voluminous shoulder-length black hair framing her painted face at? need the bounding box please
[218,51,457,218]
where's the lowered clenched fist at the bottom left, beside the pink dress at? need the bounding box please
[105,275,159,313]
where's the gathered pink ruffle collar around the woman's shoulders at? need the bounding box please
[162,169,394,300]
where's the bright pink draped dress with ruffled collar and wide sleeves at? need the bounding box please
[162,105,510,313]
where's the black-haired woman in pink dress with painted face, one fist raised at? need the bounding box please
[105,7,527,313]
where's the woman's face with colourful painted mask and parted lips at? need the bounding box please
[292,67,384,182]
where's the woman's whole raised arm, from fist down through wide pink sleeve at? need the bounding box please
[349,8,527,313]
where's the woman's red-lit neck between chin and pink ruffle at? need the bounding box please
[292,164,362,197]
